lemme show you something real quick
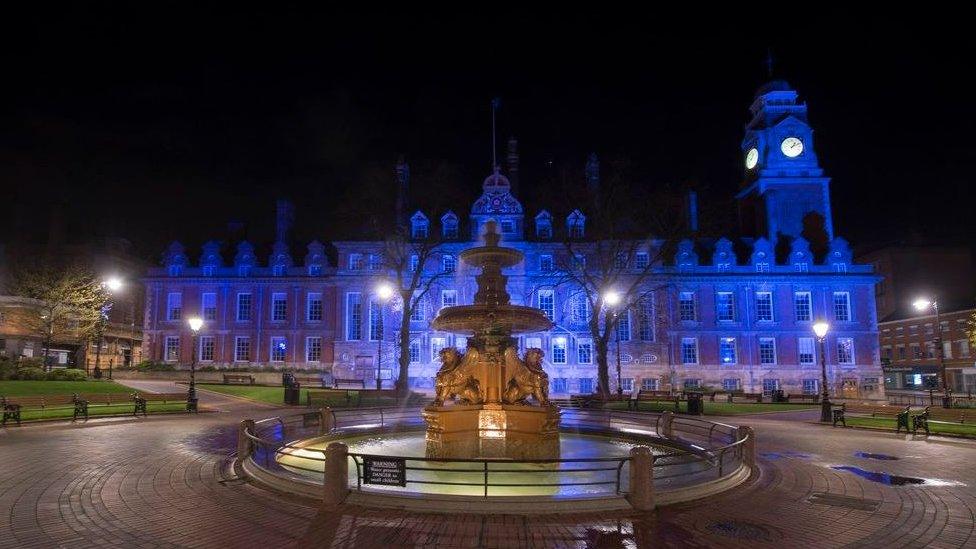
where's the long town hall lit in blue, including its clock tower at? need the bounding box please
[144,81,883,398]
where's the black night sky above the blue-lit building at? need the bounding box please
[0,9,976,259]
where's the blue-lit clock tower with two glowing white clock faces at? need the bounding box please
[736,80,834,244]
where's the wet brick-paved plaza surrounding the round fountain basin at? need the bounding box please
[0,382,976,548]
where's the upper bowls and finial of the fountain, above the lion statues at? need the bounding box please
[432,222,552,335]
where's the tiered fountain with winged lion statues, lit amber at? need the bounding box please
[423,222,559,459]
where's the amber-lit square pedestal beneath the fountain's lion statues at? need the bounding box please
[423,403,559,460]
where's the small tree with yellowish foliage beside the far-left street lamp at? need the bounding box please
[10,266,110,363]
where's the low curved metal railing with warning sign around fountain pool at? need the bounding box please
[239,408,747,497]
